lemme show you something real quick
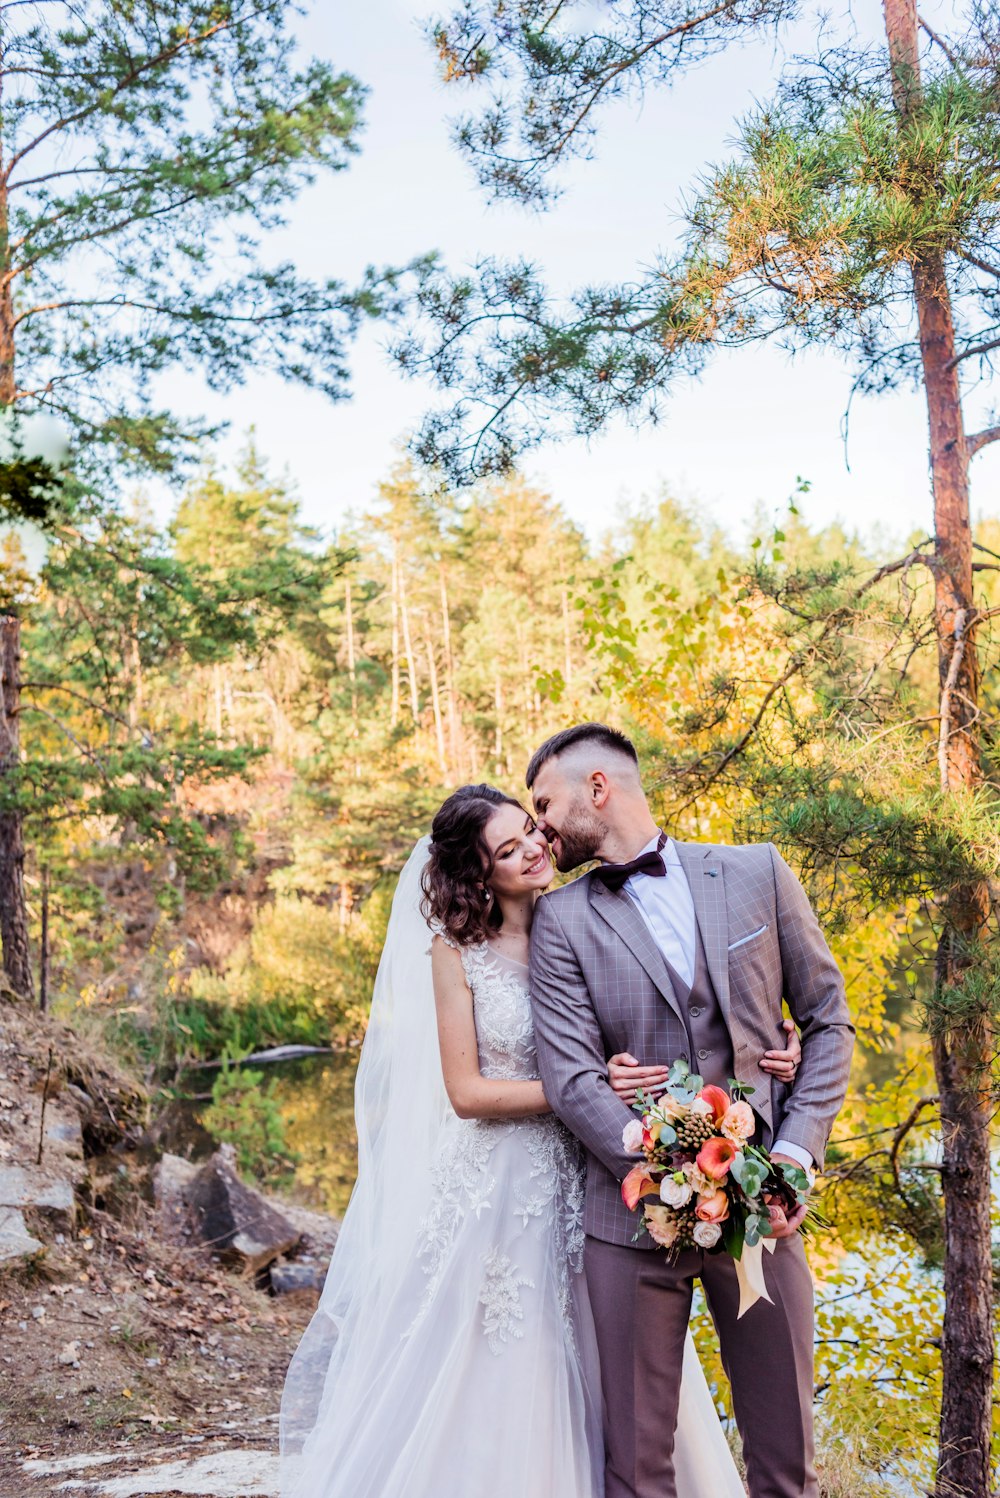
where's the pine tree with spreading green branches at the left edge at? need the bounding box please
[0,0,389,989]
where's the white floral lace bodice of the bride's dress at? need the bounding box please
[461,942,539,1082]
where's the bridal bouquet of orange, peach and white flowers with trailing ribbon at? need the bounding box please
[621,1061,808,1315]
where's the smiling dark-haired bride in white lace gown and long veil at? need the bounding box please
[281,785,799,1498]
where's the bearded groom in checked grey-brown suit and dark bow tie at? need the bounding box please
[527,724,853,1498]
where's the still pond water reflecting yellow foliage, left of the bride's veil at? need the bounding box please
[156,1050,359,1216]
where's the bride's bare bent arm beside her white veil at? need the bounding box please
[431,936,552,1119]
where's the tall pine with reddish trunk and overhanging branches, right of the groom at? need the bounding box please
[400,0,1000,1498]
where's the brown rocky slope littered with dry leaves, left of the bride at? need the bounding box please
[0,1002,335,1498]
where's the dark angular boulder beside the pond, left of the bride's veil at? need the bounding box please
[184,1144,301,1275]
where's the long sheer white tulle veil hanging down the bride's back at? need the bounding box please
[273,837,448,1498]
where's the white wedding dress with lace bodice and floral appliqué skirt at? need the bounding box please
[281,850,744,1498]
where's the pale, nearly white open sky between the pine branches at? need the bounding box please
[156,0,1000,551]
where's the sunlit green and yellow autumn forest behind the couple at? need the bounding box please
[9,440,1000,1494]
